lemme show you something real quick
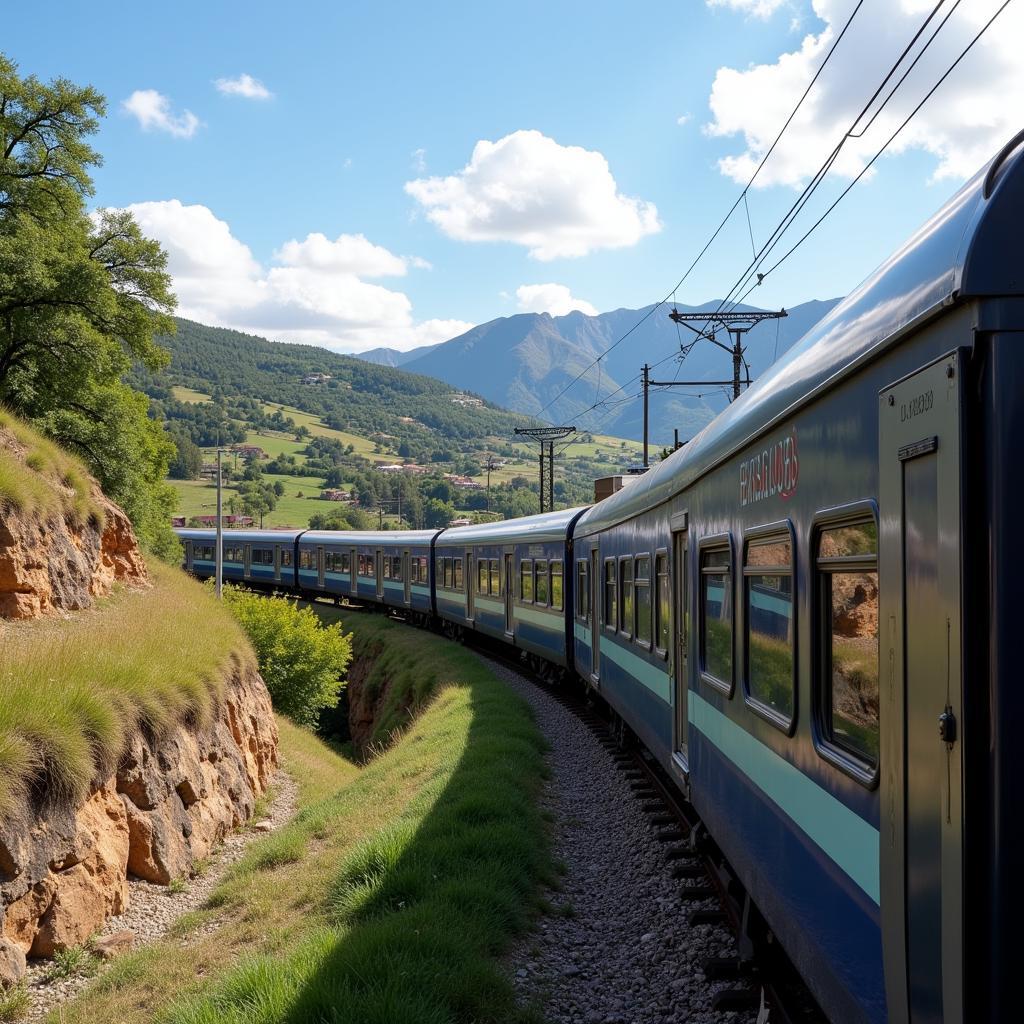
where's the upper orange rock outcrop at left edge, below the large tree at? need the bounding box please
[0,426,146,618]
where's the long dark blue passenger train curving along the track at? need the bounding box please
[178,132,1024,1024]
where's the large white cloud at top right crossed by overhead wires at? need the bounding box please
[705,0,1024,187]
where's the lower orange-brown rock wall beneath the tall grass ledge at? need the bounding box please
[0,669,278,958]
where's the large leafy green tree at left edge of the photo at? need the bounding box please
[0,54,176,552]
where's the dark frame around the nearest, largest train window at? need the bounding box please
[808,499,882,790]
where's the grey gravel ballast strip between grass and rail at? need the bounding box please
[485,658,758,1024]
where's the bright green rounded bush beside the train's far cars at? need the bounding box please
[224,586,352,728]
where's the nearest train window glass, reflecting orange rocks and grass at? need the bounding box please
[816,520,879,770]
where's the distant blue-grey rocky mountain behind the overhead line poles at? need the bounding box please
[385,299,839,443]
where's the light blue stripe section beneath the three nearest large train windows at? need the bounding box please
[687,690,880,903]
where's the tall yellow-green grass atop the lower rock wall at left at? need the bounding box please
[0,563,254,819]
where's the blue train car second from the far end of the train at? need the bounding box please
[296,529,438,615]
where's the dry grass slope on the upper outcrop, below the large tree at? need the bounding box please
[0,409,103,524]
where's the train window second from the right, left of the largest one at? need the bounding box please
[743,532,796,728]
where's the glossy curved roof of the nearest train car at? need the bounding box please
[574,132,1024,537]
